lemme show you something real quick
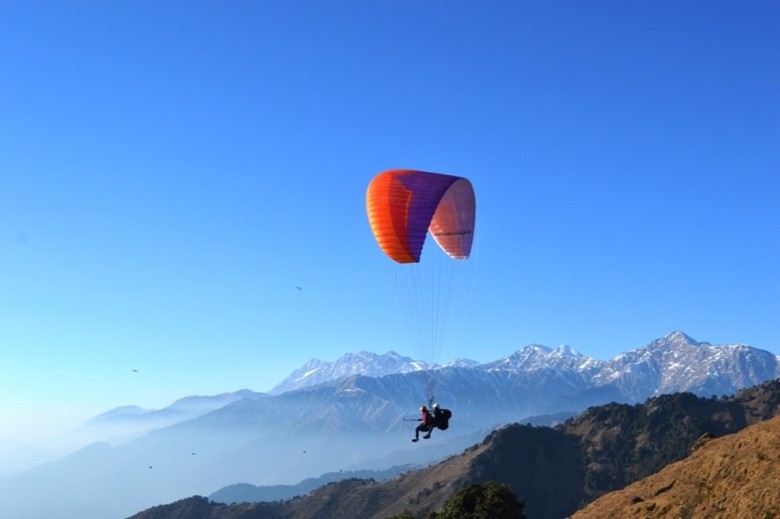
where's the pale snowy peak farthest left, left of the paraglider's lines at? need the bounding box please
[270,351,438,394]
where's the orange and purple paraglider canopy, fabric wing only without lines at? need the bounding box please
[366,169,476,263]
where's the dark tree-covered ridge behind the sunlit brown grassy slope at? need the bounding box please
[128,380,780,519]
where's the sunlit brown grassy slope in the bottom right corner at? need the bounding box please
[571,417,780,519]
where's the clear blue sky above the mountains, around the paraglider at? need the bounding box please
[0,0,780,441]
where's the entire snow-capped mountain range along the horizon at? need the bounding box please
[270,331,780,402]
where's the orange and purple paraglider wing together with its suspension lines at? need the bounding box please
[366,169,476,403]
